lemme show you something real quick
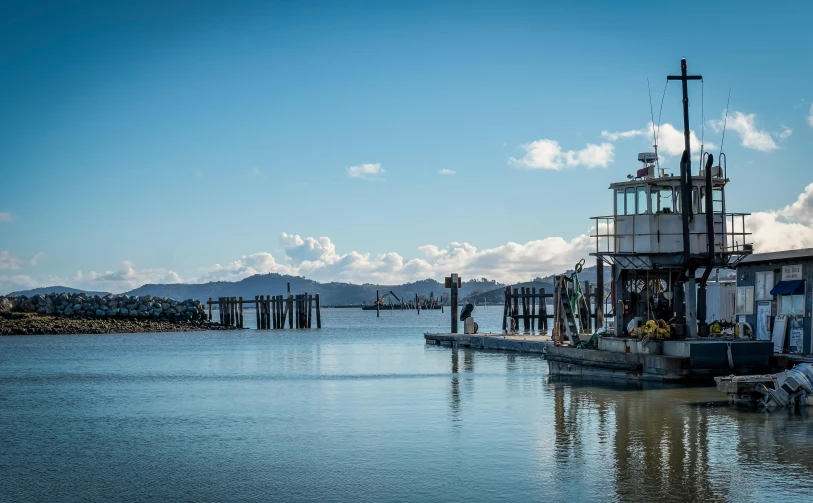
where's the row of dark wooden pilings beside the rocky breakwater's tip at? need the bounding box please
[207,293,322,330]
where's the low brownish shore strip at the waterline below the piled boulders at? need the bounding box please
[0,313,234,336]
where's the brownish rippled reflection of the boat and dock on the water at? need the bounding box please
[549,379,813,501]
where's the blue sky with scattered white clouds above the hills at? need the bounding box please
[0,0,813,294]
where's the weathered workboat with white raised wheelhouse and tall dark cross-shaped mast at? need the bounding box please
[545,59,776,381]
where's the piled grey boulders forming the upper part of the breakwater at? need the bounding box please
[0,293,207,321]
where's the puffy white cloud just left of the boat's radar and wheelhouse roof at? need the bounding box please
[508,139,614,170]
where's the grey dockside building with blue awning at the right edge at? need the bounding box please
[735,248,813,354]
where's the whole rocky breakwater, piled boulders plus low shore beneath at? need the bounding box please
[0,293,232,335]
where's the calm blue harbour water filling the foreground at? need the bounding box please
[0,308,813,502]
